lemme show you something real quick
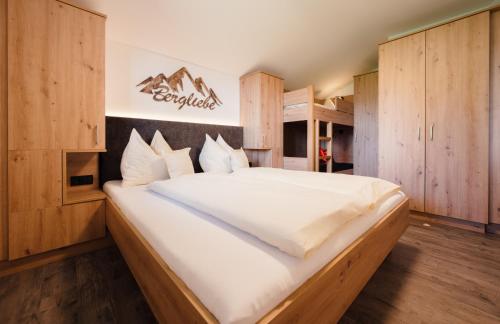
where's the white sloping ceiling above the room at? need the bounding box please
[72,0,492,98]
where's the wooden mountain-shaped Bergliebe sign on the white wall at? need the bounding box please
[137,67,222,110]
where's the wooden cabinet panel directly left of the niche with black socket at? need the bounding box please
[8,150,62,215]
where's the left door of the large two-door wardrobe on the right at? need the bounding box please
[378,32,425,211]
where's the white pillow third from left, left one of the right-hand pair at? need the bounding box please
[199,134,231,173]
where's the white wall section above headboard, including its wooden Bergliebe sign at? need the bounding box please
[106,40,240,125]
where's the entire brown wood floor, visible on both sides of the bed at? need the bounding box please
[0,221,500,324]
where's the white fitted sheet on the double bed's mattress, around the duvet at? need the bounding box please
[104,181,405,323]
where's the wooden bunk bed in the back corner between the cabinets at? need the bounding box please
[283,86,354,174]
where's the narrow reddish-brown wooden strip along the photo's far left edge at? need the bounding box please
[0,0,8,261]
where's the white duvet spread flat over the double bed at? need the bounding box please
[149,168,399,258]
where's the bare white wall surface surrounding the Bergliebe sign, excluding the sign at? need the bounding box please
[106,40,240,125]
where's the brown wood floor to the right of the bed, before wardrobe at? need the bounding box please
[342,221,500,323]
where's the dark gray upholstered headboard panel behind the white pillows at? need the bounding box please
[100,117,243,185]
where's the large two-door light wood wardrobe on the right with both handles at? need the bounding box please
[378,12,490,224]
